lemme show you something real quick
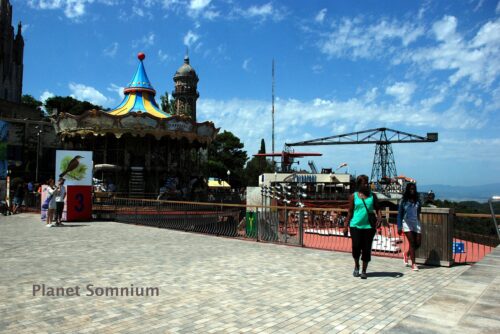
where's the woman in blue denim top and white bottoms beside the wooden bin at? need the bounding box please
[398,183,422,271]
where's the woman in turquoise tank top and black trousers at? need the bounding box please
[344,175,381,279]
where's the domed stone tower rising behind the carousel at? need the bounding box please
[172,55,200,122]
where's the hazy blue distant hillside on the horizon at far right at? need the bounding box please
[418,183,500,202]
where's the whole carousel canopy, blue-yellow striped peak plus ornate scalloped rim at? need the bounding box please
[52,53,219,144]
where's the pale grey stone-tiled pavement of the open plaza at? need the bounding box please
[0,214,500,333]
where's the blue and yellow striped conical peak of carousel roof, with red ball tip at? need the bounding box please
[109,52,170,118]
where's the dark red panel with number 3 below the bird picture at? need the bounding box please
[66,186,92,222]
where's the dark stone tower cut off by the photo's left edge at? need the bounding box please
[0,0,24,103]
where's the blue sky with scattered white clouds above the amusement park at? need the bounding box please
[11,0,500,185]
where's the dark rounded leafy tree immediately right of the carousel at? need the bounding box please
[205,131,248,188]
